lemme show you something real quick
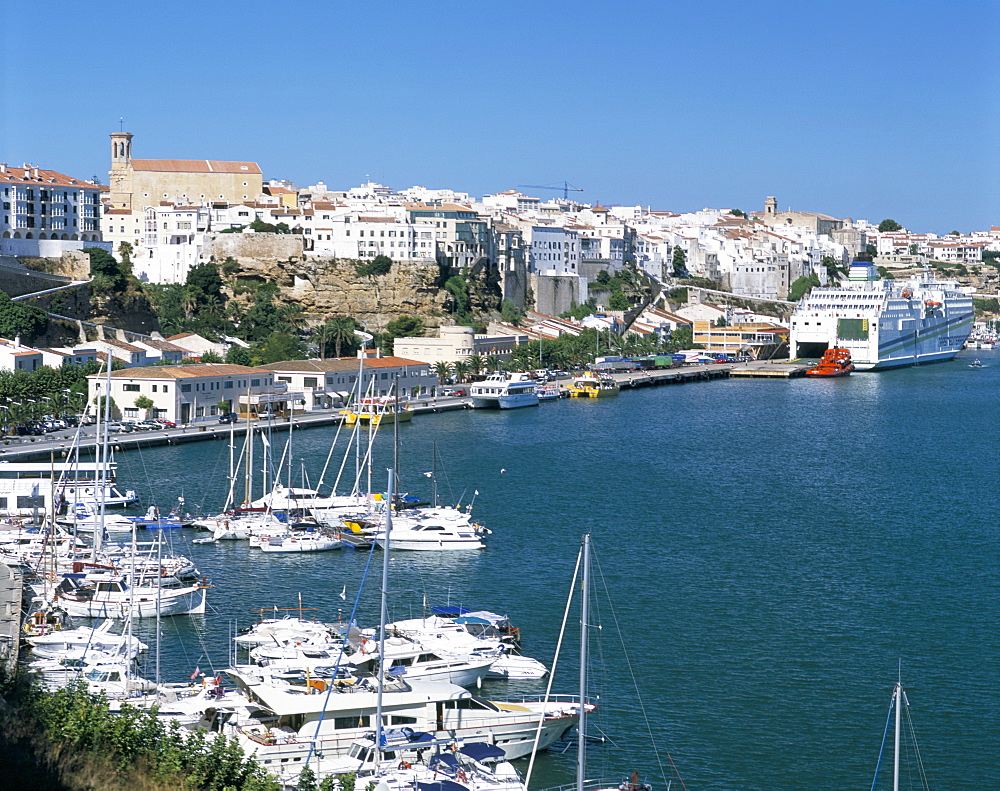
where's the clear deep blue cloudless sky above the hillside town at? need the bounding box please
[0,0,1000,233]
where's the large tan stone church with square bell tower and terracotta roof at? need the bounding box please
[108,132,264,212]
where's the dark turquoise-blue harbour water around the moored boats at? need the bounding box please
[113,352,1000,791]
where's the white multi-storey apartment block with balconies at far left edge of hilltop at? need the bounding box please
[0,162,111,258]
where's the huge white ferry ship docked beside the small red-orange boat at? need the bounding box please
[789,261,974,371]
